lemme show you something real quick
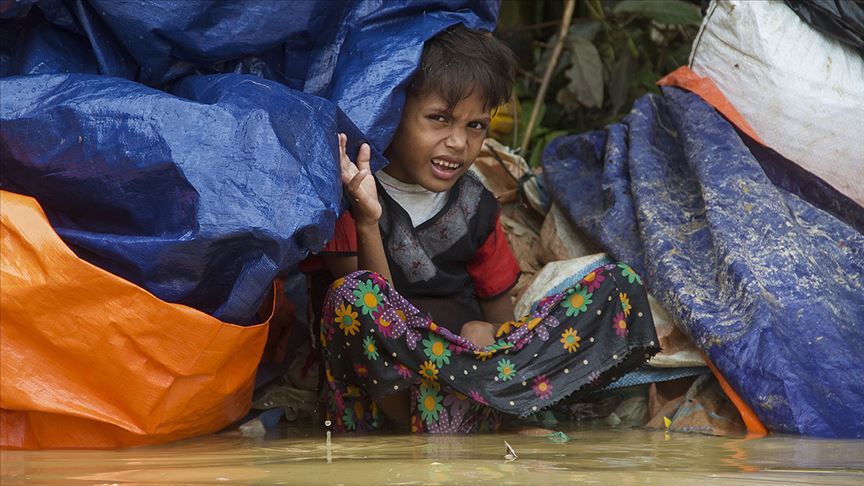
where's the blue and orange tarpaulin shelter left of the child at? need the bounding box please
[0,0,498,448]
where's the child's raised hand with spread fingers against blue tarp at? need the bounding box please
[338,133,381,224]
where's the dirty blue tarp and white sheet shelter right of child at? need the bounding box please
[543,2,864,437]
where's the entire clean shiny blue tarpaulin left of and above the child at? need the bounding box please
[0,0,498,323]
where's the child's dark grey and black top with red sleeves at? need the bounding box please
[321,172,519,334]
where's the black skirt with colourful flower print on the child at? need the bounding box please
[320,263,659,433]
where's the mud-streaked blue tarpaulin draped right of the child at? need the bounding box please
[543,88,864,437]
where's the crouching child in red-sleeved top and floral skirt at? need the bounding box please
[321,26,657,432]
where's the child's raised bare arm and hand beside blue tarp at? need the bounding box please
[324,133,393,282]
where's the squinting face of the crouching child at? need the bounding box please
[384,90,489,192]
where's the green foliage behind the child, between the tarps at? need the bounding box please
[498,0,702,166]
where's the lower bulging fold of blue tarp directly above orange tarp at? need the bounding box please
[0,74,374,324]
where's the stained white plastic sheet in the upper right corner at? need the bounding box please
[690,1,864,205]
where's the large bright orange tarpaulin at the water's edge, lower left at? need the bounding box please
[0,191,267,449]
